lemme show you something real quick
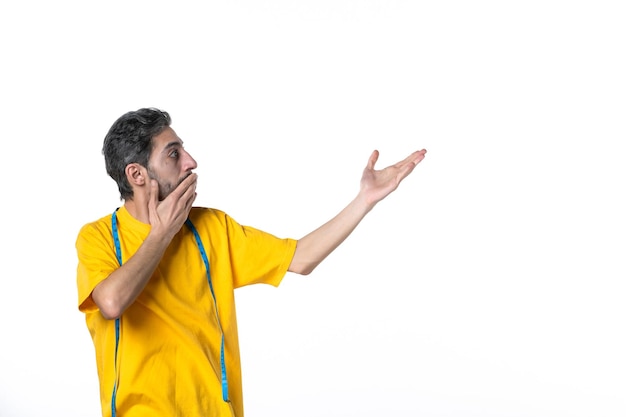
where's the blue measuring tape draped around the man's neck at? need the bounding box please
[111,208,230,417]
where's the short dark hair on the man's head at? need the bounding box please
[102,107,172,200]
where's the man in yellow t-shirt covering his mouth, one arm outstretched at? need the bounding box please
[76,108,426,417]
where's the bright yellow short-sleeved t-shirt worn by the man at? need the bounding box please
[76,207,296,417]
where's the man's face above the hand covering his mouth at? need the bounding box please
[148,127,198,201]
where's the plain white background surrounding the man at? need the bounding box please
[0,0,626,417]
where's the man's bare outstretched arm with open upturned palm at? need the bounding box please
[289,149,426,275]
